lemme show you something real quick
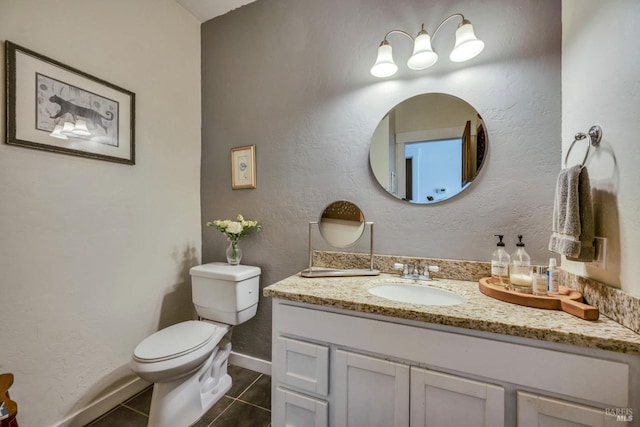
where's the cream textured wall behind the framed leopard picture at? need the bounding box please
[0,0,201,427]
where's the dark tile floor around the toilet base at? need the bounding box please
[88,366,271,427]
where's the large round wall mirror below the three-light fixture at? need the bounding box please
[369,93,488,204]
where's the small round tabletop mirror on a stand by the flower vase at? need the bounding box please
[318,200,365,248]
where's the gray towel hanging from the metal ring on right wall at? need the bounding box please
[549,165,595,262]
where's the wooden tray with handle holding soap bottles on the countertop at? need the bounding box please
[480,277,600,320]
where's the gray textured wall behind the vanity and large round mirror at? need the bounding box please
[201,0,561,360]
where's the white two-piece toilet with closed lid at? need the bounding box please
[130,262,260,427]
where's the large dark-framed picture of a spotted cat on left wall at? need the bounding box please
[5,40,135,165]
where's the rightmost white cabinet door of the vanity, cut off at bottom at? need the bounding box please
[518,391,624,427]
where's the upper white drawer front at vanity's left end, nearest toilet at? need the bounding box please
[275,337,329,396]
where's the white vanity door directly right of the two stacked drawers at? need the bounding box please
[334,350,409,427]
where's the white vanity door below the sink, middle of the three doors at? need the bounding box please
[411,367,505,427]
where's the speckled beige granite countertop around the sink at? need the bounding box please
[264,273,640,354]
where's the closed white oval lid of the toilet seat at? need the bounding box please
[133,320,220,362]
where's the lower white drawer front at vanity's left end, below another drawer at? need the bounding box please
[272,387,329,427]
